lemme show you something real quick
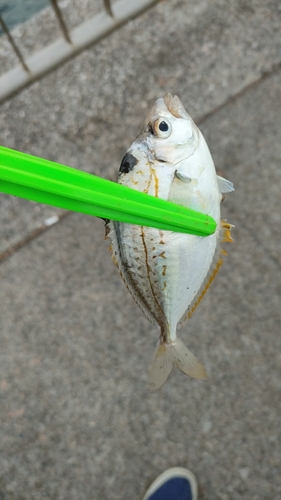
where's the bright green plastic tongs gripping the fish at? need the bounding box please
[0,146,216,236]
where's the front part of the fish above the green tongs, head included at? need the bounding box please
[118,94,221,215]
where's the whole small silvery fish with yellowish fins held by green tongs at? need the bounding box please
[106,93,234,390]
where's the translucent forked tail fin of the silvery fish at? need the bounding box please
[149,337,207,391]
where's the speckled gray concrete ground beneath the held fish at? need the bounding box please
[0,0,281,500]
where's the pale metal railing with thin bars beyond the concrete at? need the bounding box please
[0,0,159,104]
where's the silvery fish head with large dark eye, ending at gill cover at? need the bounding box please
[134,94,199,165]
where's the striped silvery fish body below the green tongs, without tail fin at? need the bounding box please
[110,222,217,342]
